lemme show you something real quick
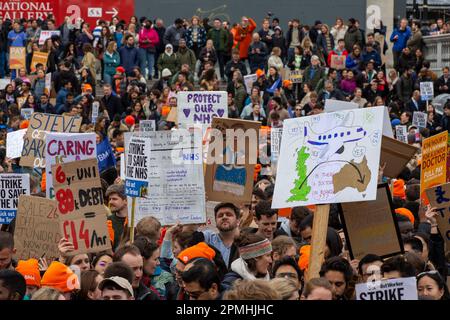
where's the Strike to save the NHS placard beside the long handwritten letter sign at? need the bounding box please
[125,137,151,198]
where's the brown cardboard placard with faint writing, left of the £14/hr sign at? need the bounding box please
[14,195,62,261]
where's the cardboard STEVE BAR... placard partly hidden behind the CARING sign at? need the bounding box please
[20,112,82,168]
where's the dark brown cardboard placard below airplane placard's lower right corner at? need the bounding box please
[339,184,403,260]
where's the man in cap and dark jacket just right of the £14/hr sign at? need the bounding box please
[106,184,128,251]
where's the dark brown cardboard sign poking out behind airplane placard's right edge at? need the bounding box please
[380,136,418,178]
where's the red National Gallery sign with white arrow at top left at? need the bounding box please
[0,0,134,28]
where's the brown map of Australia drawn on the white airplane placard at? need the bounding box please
[333,157,371,193]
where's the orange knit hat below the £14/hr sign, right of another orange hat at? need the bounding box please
[41,261,80,293]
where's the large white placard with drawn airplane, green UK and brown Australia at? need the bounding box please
[272,107,384,208]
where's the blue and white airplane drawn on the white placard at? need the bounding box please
[304,112,367,159]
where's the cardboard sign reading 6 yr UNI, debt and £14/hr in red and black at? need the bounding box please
[52,159,111,254]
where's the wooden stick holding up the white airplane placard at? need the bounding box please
[306,204,330,281]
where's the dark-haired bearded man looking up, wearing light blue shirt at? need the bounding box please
[203,203,240,268]
